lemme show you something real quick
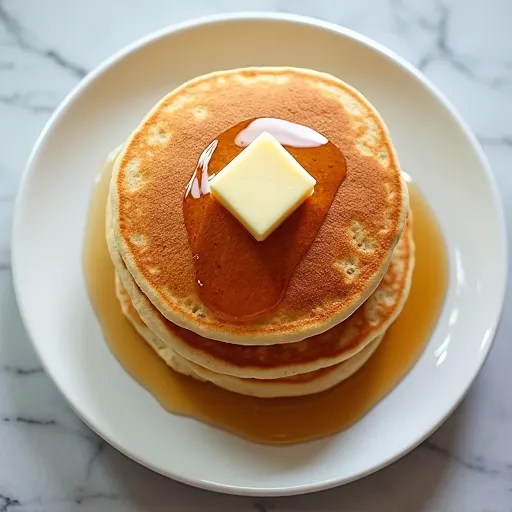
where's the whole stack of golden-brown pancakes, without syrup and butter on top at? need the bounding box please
[106,68,414,398]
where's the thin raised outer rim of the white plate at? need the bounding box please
[10,11,509,497]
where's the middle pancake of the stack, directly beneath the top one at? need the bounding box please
[107,198,414,379]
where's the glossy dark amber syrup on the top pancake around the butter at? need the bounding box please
[183,118,346,321]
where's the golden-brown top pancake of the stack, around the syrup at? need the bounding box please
[110,68,408,345]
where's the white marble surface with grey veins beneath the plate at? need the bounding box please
[0,0,512,512]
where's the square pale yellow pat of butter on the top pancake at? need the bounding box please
[210,132,316,241]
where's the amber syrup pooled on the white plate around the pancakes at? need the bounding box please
[84,158,448,444]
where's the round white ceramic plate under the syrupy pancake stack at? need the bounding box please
[13,14,507,495]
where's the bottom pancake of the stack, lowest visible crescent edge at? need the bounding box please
[116,274,384,398]
